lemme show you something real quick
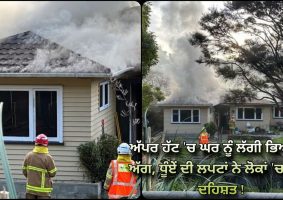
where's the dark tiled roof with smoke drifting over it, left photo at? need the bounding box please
[0,31,111,74]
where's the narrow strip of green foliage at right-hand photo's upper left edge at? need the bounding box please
[142,2,158,77]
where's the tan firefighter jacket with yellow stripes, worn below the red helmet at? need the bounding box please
[23,152,57,196]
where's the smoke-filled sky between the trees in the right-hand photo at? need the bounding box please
[149,1,234,104]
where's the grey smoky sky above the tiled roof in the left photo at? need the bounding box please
[0,1,141,72]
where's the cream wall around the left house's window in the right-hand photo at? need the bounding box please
[163,107,210,134]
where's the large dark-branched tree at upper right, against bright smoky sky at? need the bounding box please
[189,1,283,105]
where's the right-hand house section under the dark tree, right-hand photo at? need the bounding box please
[215,100,283,134]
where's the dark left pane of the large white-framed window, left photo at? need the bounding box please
[0,91,29,137]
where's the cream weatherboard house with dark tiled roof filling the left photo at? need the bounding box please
[0,31,116,182]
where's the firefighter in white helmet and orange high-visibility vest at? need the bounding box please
[104,143,137,199]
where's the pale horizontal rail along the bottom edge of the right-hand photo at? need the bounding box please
[142,191,283,199]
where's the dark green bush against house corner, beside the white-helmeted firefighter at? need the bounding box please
[78,134,119,182]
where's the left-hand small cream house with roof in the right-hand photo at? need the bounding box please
[158,99,213,135]
